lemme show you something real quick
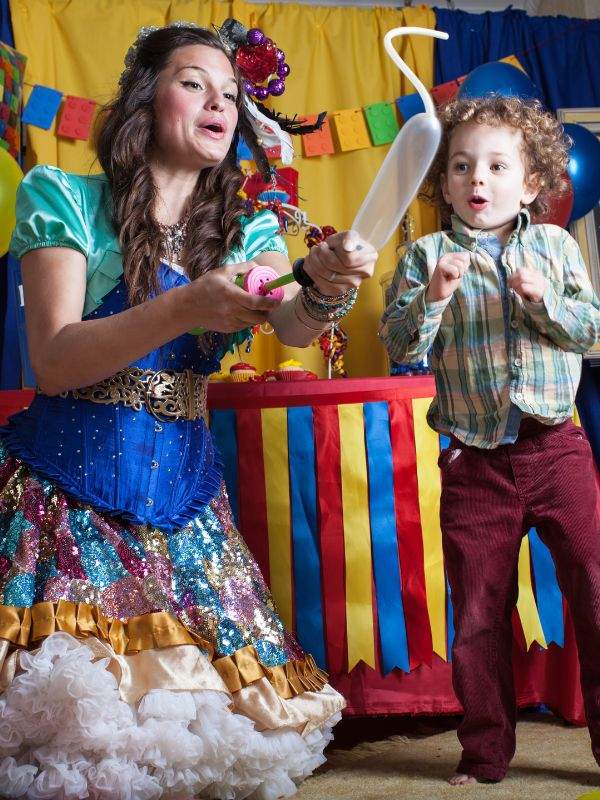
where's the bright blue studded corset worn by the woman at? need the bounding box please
[1,265,222,530]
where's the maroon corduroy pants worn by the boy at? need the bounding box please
[439,419,600,780]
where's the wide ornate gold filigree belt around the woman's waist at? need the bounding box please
[63,367,208,422]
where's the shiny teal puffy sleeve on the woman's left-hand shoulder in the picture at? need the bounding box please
[10,166,90,258]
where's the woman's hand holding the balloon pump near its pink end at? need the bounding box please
[192,261,281,333]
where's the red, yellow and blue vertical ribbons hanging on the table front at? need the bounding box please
[211,390,564,674]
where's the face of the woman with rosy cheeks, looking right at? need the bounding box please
[154,44,238,170]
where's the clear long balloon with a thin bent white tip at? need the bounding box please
[352,27,448,250]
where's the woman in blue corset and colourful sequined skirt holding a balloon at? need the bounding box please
[0,18,376,799]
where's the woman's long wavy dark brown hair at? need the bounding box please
[96,26,266,305]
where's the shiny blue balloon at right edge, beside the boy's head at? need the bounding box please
[563,122,600,222]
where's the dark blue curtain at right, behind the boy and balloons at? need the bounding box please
[435,8,600,466]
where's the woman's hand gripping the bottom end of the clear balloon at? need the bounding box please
[304,231,377,297]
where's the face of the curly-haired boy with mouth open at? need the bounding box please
[442,122,539,242]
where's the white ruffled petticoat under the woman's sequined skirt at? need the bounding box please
[0,633,340,800]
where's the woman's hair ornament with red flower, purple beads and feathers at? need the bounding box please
[119,18,326,169]
